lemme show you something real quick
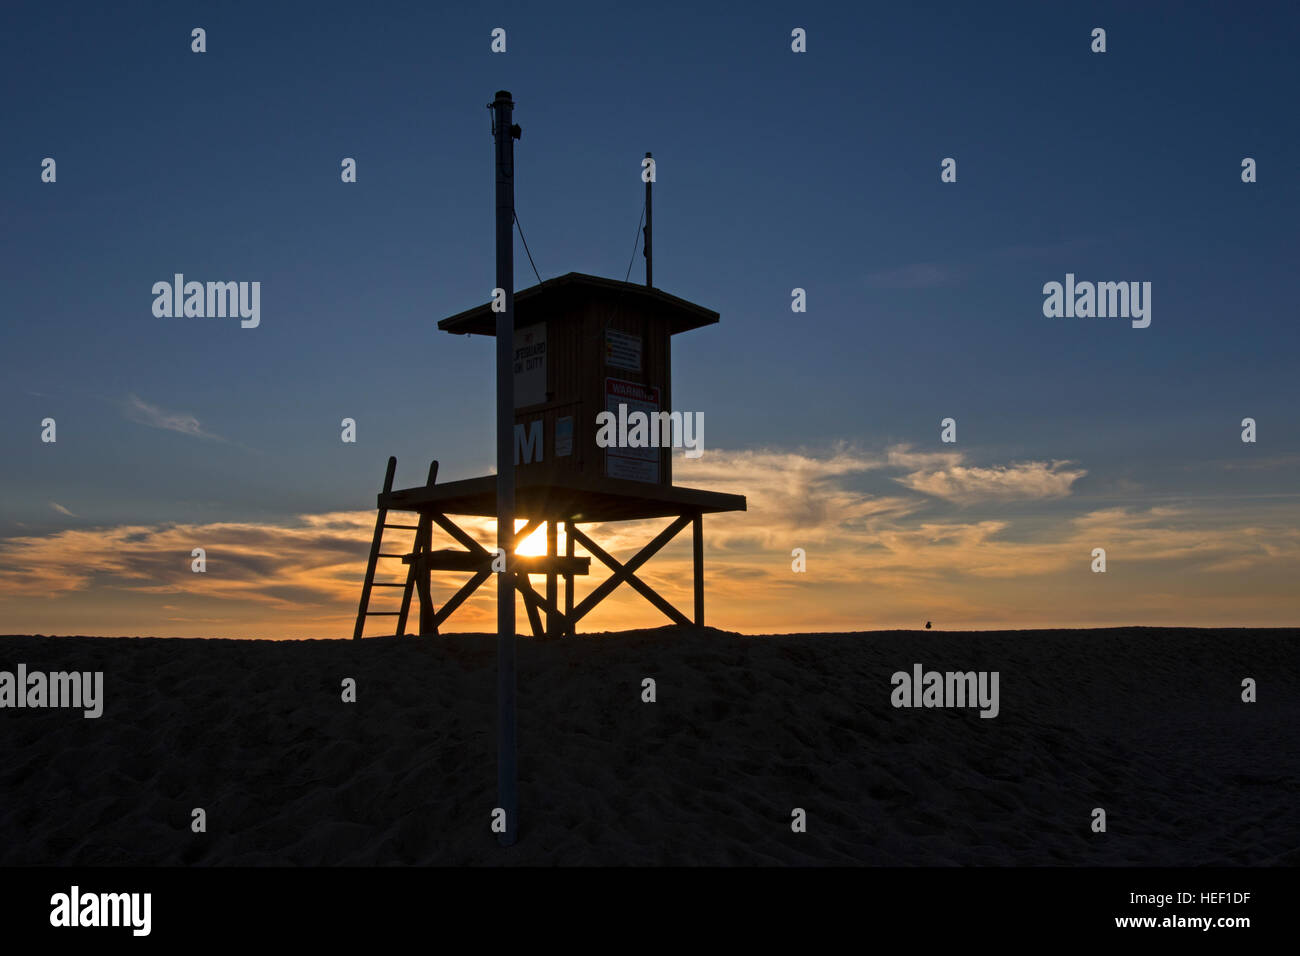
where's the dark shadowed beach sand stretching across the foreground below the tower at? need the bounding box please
[0,628,1300,866]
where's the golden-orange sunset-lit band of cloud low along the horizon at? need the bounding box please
[0,445,1300,637]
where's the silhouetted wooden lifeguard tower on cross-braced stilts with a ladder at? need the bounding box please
[352,130,745,639]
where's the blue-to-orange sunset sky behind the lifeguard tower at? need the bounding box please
[0,1,1300,637]
